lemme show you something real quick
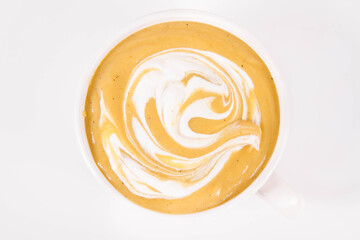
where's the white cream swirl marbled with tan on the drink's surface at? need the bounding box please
[100,48,261,199]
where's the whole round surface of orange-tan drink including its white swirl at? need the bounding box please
[84,21,280,214]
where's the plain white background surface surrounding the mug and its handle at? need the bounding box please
[0,0,360,239]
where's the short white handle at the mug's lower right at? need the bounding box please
[257,173,304,218]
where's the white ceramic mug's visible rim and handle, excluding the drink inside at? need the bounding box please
[75,10,303,217]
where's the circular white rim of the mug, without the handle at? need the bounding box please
[75,9,289,217]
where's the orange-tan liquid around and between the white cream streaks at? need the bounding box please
[84,22,280,214]
